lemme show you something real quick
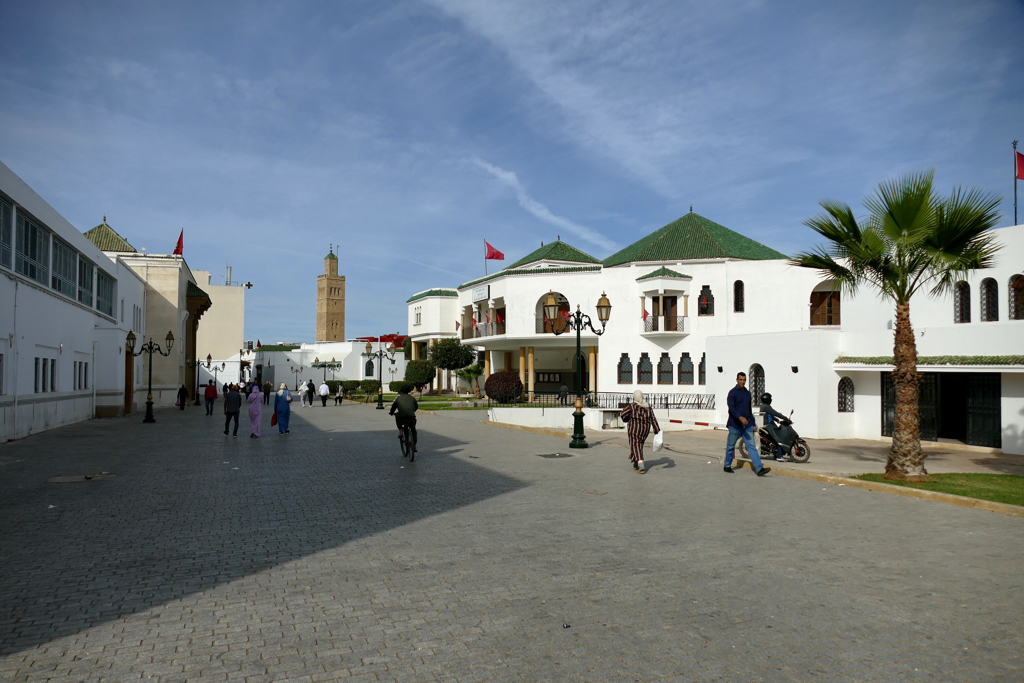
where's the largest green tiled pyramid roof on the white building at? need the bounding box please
[602,211,786,266]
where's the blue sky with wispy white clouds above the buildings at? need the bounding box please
[0,0,1024,342]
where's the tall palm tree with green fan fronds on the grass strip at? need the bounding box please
[792,170,999,481]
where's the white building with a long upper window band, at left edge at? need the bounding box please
[0,163,145,440]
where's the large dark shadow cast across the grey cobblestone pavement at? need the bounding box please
[0,410,525,654]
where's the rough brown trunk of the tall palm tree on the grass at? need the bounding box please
[885,302,928,481]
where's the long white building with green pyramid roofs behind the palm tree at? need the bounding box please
[409,212,1024,454]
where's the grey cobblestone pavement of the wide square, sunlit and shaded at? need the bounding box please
[0,404,1024,683]
